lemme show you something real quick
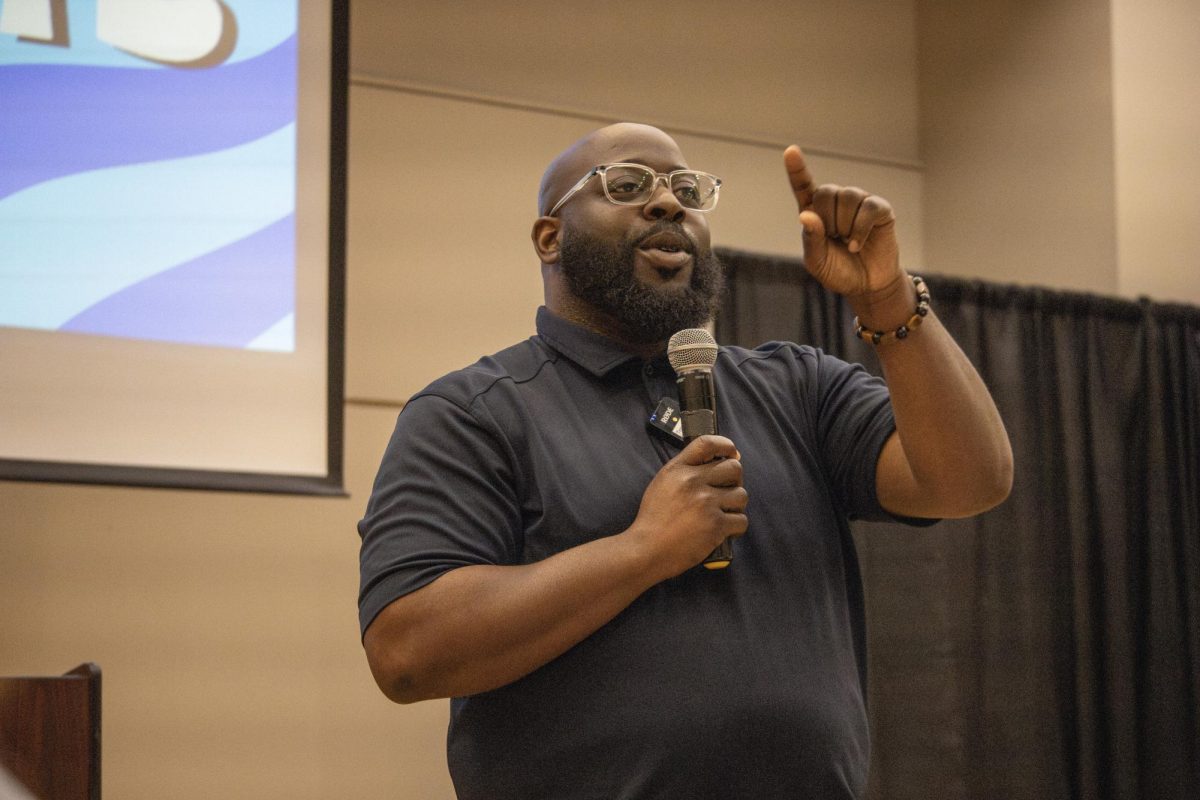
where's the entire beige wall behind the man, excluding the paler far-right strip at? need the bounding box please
[0,0,1196,800]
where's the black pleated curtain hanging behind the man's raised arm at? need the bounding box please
[716,249,1200,800]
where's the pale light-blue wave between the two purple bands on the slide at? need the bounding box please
[0,124,295,330]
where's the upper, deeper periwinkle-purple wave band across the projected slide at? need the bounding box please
[0,36,296,198]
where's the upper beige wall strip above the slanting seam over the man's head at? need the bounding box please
[352,0,918,162]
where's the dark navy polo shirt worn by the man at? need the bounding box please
[359,303,894,800]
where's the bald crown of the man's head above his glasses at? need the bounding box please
[538,122,688,216]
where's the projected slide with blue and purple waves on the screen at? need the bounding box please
[0,0,298,353]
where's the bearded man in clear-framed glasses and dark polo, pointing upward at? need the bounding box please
[360,124,1012,800]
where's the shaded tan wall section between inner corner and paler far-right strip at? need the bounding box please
[917,0,1118,294]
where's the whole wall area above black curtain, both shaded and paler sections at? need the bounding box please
[917,0,1200,305]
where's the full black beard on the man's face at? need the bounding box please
[559,221,725,344]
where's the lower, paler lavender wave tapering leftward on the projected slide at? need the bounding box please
[60,215,295,349]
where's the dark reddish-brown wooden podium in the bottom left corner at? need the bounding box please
[0,663,100,800]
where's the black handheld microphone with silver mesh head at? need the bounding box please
[667,327,733,570]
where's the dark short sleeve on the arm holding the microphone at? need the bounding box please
[359,395,520,632]
